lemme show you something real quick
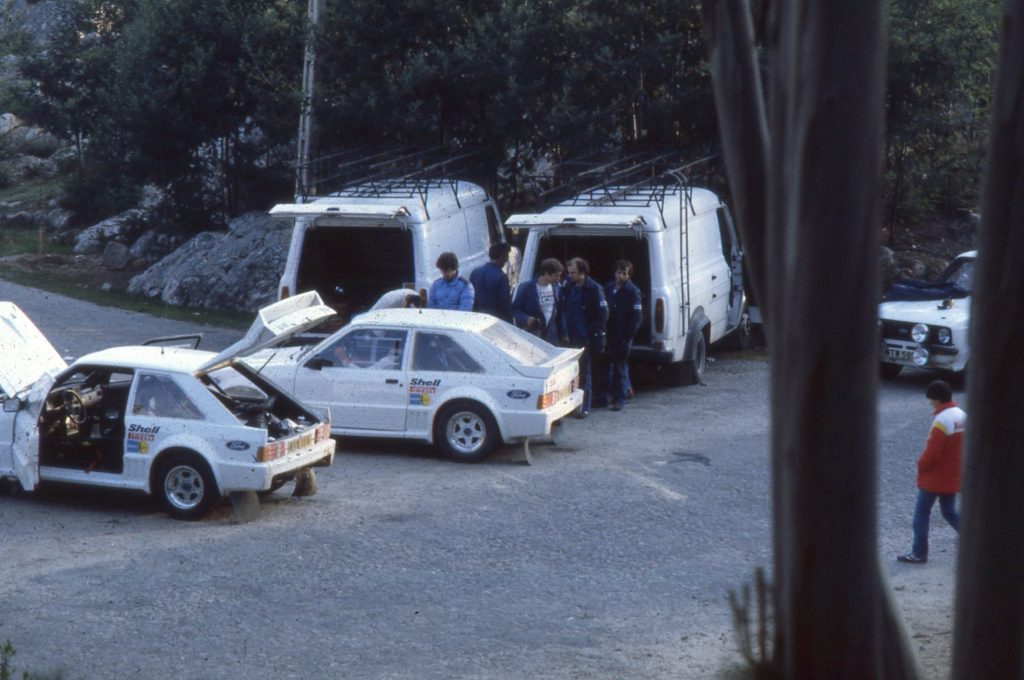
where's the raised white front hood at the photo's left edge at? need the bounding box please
[0,302,68,396]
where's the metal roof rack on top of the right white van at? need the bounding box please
[524,152,718,219]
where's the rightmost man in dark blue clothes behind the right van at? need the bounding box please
[604,260,643,411]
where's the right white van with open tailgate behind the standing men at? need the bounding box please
[506,174,750,384]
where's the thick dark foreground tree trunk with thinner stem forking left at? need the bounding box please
[705,0,914,678]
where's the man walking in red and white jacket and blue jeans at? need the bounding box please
[896,380,967,564]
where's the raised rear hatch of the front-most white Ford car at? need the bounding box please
[198,291,335,374]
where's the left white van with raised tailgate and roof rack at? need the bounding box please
[270,178,505,325]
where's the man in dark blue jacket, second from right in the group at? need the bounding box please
[558,257,608,418]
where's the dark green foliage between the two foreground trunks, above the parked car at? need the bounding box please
[884,0,997,238]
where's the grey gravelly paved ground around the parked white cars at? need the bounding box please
[0,282,955,680]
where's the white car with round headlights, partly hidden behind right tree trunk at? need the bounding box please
[879,251,977,378]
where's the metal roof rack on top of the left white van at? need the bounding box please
[295,145,485,208]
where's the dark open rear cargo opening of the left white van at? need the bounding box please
[296,226,416,323]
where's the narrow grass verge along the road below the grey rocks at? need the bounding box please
[0,263,255,330]
